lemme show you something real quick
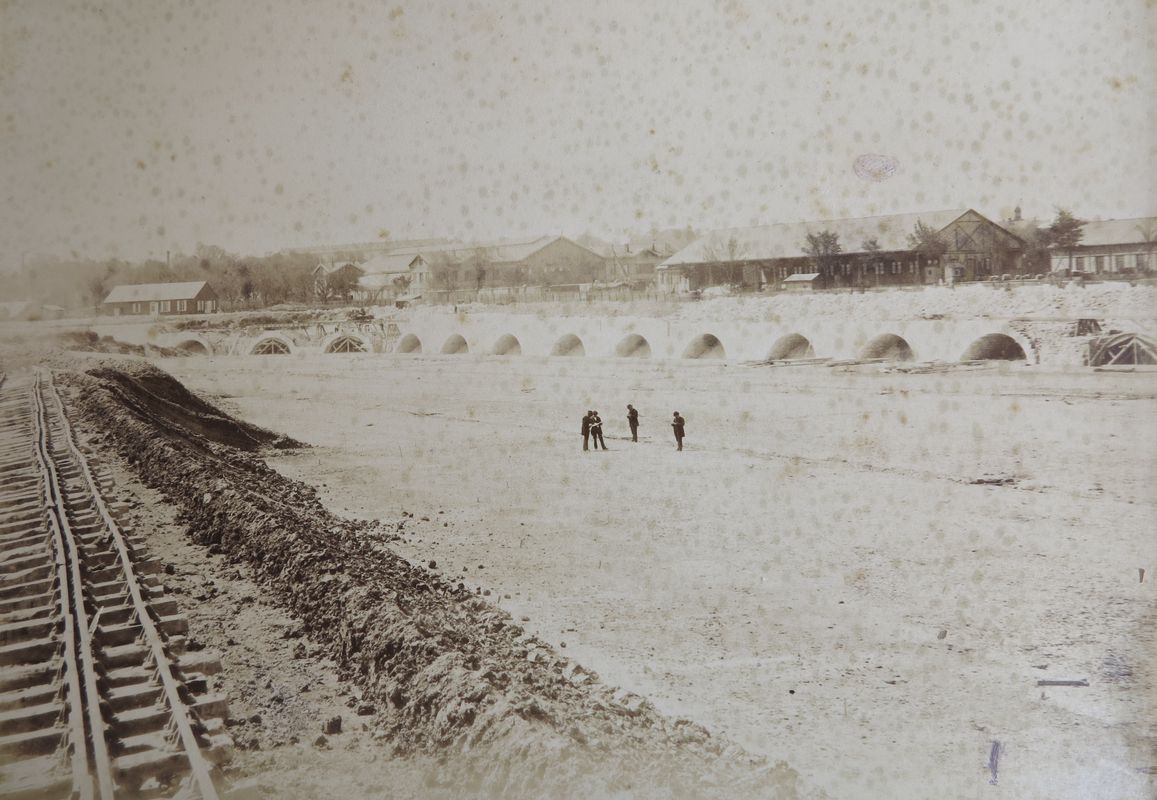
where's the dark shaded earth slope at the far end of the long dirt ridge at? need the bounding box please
[87,361,301,450]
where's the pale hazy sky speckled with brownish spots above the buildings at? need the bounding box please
[0,0,1157,269]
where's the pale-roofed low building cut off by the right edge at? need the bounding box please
[1052,216,1157,274]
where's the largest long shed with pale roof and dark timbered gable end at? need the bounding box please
[657,208,1023,292]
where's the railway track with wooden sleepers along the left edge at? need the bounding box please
[0,372,231,800]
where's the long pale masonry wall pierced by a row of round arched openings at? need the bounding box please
[135,311,1059,364]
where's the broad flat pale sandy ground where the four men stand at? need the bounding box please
[161,355,1157,798]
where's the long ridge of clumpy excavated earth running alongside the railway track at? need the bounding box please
[67,368,801,798]
